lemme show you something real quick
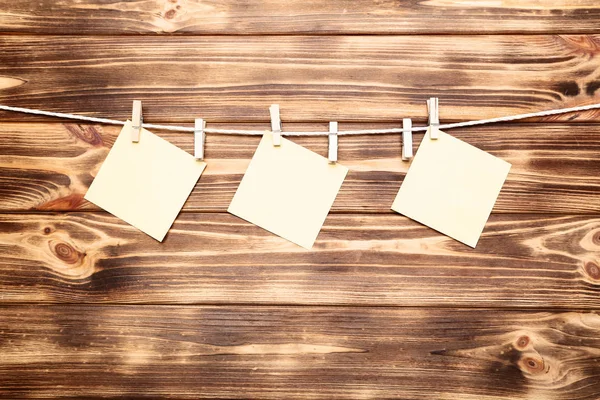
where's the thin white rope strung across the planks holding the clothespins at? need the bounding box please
[0,103,600,136]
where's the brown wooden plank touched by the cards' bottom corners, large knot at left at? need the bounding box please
[0,213,600,308]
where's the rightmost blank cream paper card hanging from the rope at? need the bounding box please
[392,131,511,247]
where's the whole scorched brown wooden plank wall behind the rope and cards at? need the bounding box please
[0,0,600,400]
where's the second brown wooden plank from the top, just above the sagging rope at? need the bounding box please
[0,35,600,125]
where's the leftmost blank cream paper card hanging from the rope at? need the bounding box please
[85,121,206,241]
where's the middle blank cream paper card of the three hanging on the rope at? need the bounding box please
[228,132,348,249]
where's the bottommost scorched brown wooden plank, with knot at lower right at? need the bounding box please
[0,305,600,400]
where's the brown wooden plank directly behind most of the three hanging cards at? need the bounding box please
[0,123,600,214]
